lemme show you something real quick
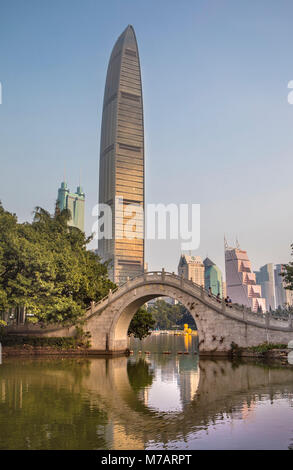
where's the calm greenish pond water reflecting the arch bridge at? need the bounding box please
[0,335,293,449]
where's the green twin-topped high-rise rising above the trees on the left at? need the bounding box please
[57,181,85,232]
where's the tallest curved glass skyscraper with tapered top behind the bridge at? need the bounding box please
[98,26,144,284]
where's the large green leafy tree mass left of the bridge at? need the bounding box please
[0,204,114,324]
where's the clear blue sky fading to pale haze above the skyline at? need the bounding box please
[0,0,293,271]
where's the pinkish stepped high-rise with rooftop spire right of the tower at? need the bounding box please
[225,244,266,312]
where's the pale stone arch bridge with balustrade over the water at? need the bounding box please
[9,270,293,354]
